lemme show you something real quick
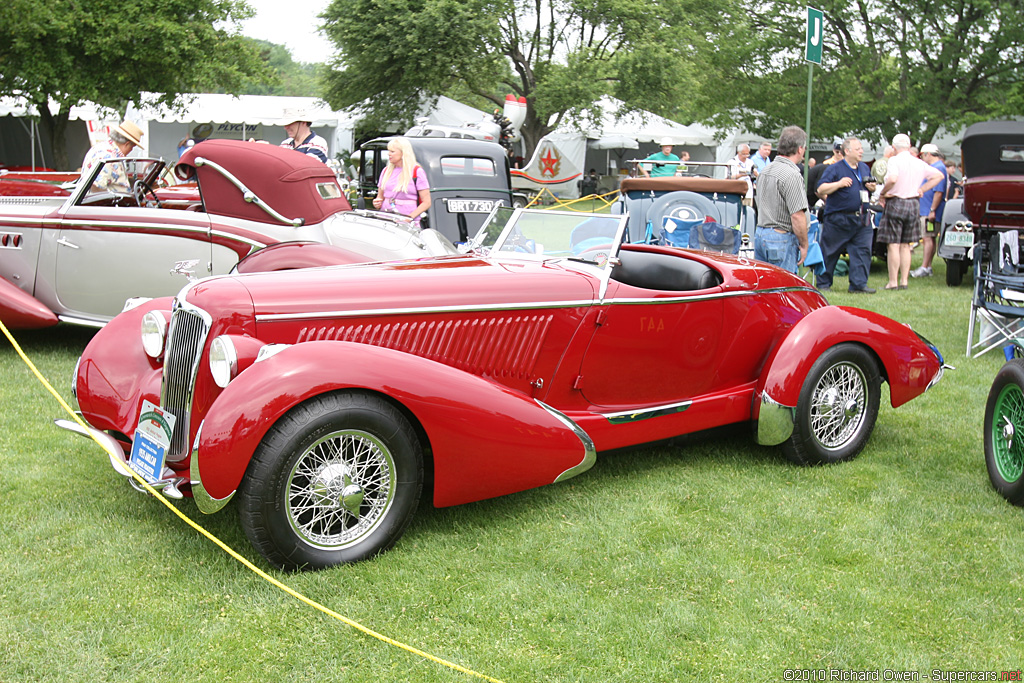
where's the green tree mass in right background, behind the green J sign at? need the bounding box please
[701,0,1024,144]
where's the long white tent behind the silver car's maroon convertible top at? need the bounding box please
[127,93,354,159]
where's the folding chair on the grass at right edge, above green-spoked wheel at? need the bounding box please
[967,230,1024,358]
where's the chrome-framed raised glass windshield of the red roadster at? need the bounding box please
[471,207,626,266]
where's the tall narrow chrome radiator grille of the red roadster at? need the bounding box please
[160,303,210,462]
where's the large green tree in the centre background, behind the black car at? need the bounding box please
[322,0,731,154]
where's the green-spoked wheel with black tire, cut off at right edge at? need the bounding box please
[985,358,1024,505]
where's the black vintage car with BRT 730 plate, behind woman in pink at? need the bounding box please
[358,137,517,243]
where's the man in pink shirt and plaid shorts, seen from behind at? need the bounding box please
[878,133,942,290]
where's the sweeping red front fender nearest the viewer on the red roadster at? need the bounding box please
[193,341,594,507]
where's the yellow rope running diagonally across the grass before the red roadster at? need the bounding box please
[0,321,502,683]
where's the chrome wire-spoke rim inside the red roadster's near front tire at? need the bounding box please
[287,429,395,550]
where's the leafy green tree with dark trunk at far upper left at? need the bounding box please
[0,0,268,168]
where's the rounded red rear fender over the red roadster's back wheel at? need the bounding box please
[754,306,941,417]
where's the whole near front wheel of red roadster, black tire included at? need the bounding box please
[239,392,423,570]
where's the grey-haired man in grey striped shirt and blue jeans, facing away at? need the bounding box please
[754,126,807,272]
